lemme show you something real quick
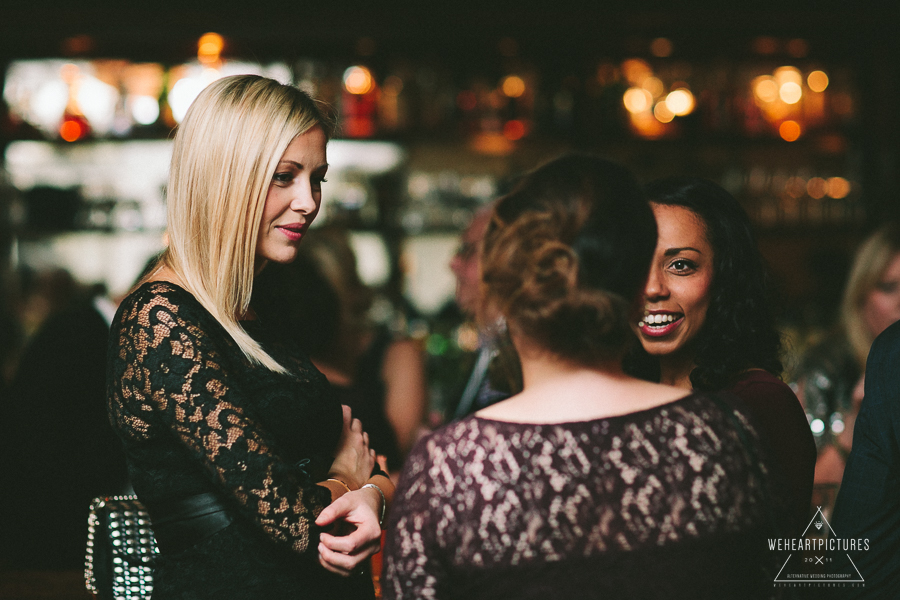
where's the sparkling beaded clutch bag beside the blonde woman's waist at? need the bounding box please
[84,496,159,600]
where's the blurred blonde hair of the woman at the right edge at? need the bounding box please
[841,223,900,370]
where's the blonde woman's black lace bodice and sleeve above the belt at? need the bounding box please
[108,282,341,553]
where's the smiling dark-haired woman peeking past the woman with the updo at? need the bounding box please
[631,177,816,532]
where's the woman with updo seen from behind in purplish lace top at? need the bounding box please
[382,155,771,599]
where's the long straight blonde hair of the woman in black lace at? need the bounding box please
[153,75,333,372]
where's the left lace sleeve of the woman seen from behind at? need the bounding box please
[381,436,451,600]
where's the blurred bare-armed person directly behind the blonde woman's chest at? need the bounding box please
[254,227,426,473]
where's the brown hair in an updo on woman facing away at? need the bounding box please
[482,154,656,365]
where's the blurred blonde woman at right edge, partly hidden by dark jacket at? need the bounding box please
[796,223,900,516]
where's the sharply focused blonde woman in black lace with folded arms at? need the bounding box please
[108,75,393,600]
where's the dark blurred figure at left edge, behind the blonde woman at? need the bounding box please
[0,271,128,570]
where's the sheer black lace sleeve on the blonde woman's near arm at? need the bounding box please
[110,293,331,553]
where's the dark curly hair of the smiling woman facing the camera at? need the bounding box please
[626,177,783,391]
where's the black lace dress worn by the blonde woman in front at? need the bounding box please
[108,282,373,600]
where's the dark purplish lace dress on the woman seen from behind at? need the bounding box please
[382,394,775,599]
